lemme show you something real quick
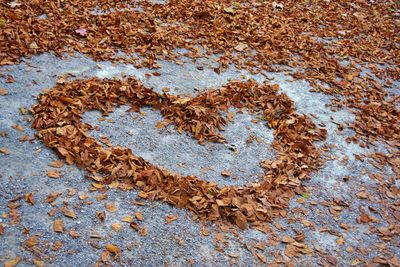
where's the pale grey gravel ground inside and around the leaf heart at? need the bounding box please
[0,54,400,266]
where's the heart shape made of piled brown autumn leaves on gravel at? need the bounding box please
[33,78,326,228]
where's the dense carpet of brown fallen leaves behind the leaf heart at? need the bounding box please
[0,0,400,147]
